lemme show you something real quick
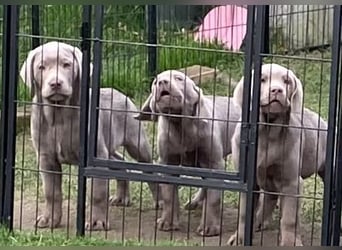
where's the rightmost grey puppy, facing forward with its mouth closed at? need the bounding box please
[228,64,327,246]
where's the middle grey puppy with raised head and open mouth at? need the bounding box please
[137,70,240,236]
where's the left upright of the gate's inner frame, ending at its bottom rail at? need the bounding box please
[88,5,103,164]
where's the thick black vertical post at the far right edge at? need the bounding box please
[321,5,341,246]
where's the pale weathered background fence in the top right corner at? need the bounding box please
[270,5,333,53]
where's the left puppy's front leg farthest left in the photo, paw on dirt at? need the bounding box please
[36,155,62,228]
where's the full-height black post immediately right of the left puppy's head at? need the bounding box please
[76,5,91,236]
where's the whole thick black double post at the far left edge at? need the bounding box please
[1,5,20,230]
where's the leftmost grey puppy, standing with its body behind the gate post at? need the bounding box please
[20,41,157,230]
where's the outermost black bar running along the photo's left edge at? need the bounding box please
[0,5,11,222]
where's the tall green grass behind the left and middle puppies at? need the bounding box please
[12,5,243,103]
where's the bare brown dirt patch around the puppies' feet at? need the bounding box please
[14,199,321,246]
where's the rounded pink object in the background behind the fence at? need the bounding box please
[195,5,247,51]
